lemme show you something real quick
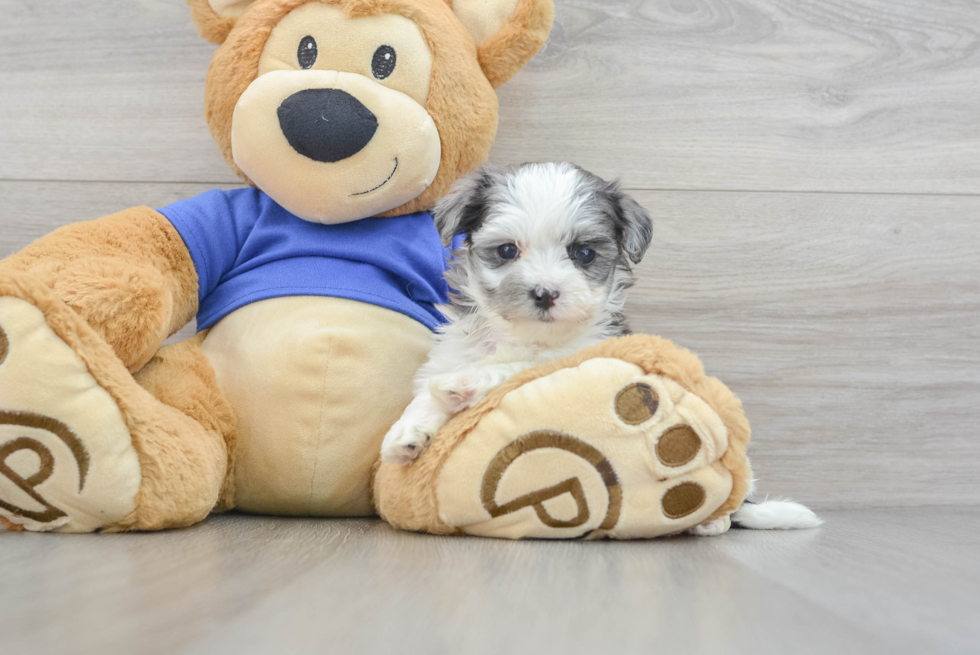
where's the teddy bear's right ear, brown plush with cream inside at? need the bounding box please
[451,0,555,88]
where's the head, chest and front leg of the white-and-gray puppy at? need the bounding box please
[381,164,653,464]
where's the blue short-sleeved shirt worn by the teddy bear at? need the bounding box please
[159,188,448,330]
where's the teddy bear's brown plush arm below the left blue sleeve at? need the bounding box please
[0,207,198,371]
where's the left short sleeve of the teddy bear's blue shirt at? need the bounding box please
[158,189,261,299]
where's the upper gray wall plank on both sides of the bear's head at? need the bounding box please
[0,0,980,194]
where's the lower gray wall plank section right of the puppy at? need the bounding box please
[628,192,980,506]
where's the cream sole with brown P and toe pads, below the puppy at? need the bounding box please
[436,358,732,539]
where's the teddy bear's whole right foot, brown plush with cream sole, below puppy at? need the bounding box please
[375,335,751,538]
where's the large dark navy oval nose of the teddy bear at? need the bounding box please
[279,89,378,163]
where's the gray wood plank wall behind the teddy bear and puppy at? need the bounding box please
[0,0,980,507]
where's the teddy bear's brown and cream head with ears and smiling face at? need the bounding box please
[188,0,554,224]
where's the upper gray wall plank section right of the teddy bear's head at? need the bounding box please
[502,0,980,193]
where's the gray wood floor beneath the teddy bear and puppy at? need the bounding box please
[0,508,980,655]
